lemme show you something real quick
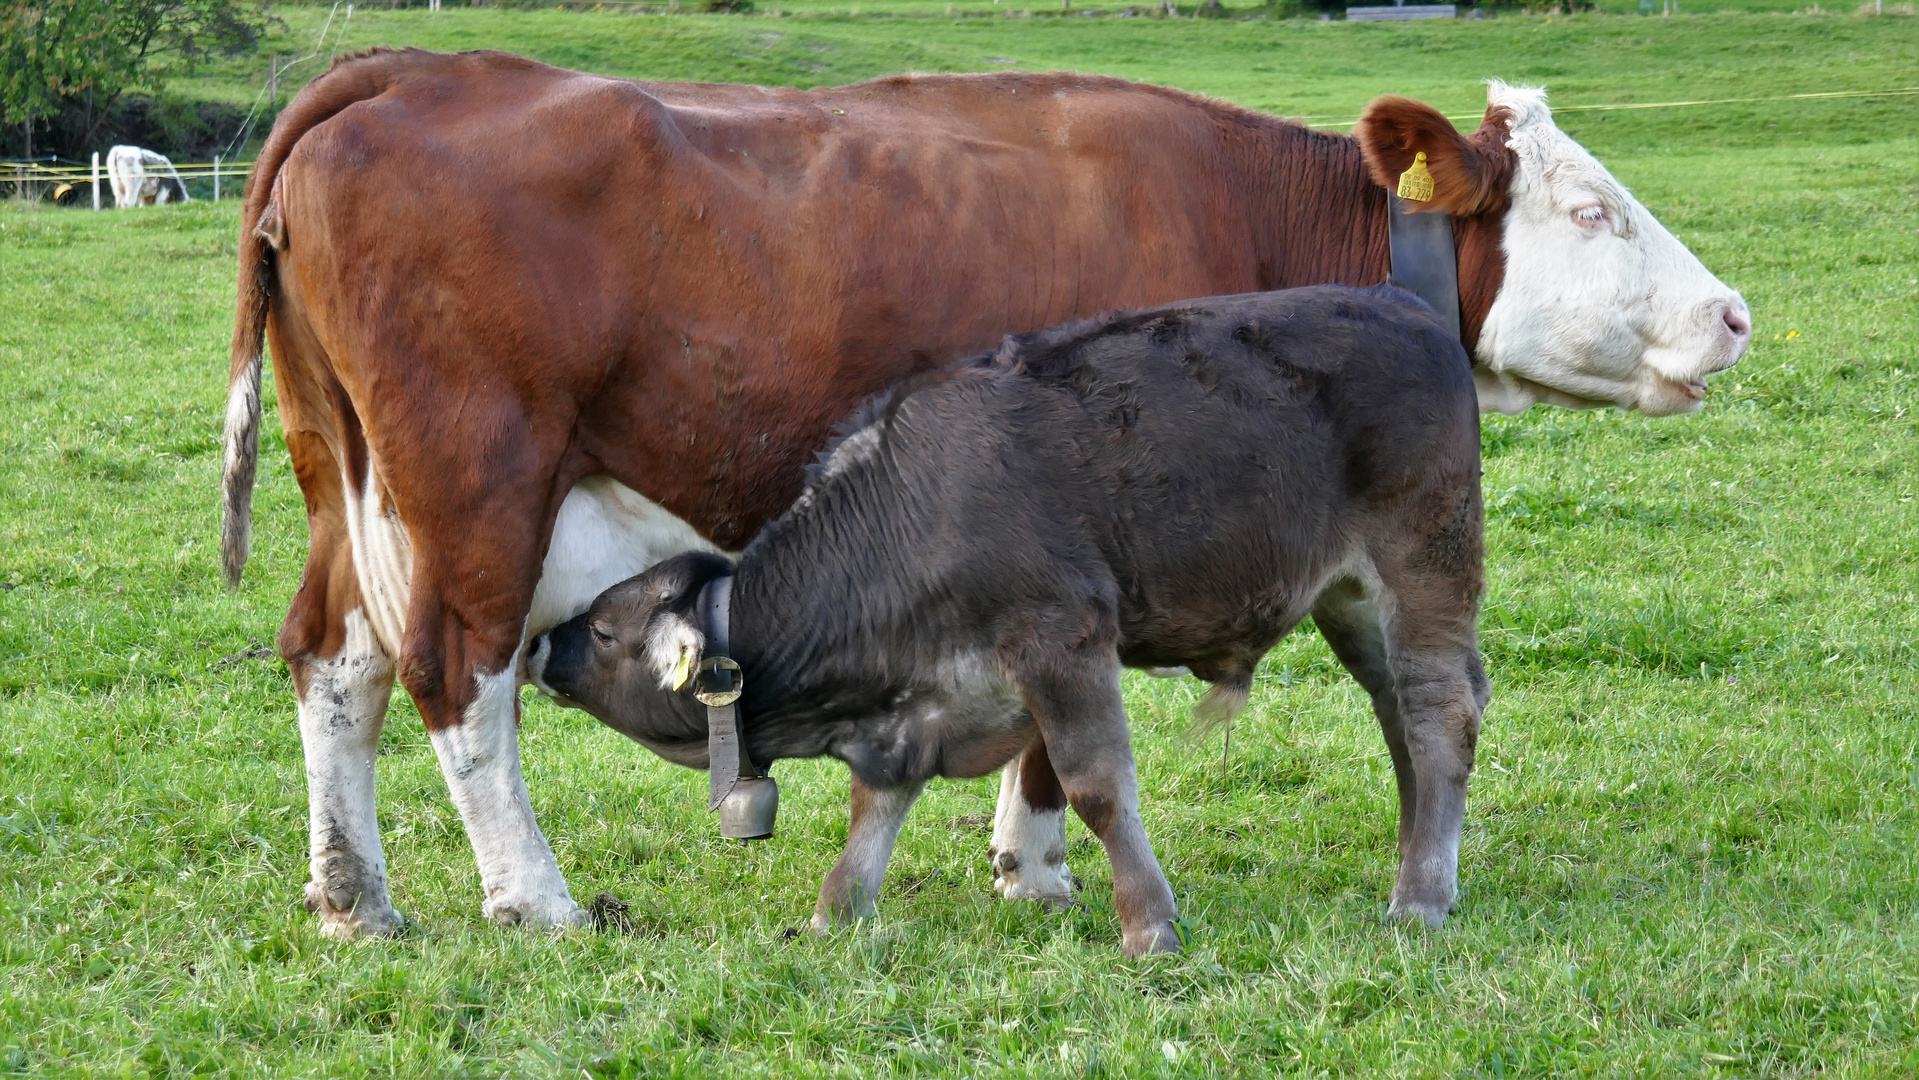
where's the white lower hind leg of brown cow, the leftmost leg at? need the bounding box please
[288,608,403,938]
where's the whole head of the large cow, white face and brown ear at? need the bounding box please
[1355,81,1752,416]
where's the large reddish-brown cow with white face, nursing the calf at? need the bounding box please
[223,50,1750,934]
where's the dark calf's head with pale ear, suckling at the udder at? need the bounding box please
[526,551,733,769]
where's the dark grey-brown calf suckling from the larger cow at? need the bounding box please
[528,286,1487,955]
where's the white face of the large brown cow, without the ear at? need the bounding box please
[1478,82,1752,416]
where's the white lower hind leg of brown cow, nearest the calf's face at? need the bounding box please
[416,664,585,928]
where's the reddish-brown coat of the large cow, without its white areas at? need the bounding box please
[234,50,1503,727]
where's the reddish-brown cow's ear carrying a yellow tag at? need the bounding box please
[1353,96,1514,217]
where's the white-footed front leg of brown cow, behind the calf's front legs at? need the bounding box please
[986,739,1073,907]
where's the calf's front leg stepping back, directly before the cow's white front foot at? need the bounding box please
[1021,660,1180,959]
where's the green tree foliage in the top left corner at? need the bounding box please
[0,0,265,132]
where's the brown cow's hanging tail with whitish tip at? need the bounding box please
[221,50,427,585]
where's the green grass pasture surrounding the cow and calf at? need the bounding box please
[0,8,1919,1076]
